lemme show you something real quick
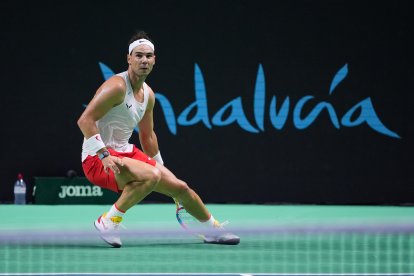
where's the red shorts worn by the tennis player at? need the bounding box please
[82,145,156,193]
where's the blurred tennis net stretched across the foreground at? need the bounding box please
[0,223,414,275]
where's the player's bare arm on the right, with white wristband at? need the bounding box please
[138,87,164,165]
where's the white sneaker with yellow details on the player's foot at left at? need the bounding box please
[94,213,122,248]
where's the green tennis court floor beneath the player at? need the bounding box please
[0,203,414,275]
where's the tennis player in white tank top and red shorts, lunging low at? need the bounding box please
[78,31,240,247]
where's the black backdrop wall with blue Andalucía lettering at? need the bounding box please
[0,0,414,204]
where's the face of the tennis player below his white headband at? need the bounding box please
[128,45,155,76]
